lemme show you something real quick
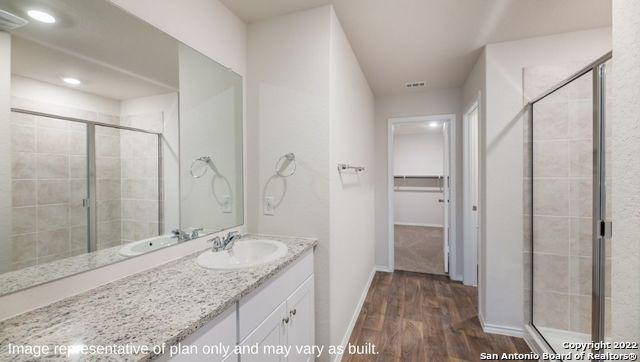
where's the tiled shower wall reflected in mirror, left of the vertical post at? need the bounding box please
[11,112,87,269]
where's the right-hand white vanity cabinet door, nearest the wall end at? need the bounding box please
[287,275,315,361]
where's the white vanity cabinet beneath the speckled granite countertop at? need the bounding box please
[166,250,315,362]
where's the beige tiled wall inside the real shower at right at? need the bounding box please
[524,64,610,334]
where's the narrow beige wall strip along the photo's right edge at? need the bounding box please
[612,0,640,344]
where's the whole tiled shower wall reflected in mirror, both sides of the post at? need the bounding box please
[9,100,163,270]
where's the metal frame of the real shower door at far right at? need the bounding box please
[525,52,612,351]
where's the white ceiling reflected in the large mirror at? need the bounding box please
[0,0,179,100]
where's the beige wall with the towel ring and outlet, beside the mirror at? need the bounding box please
[246,6,330,354]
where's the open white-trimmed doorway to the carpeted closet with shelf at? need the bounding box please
[388,115,456,275]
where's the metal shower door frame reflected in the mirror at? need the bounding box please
[11,107,164,253]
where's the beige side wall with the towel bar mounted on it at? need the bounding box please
[329,5,376,350]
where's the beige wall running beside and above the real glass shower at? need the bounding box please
[464,28,611,334]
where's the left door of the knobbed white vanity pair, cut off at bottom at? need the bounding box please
[240,302,287,362]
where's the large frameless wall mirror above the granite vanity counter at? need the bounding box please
[0,0,244,295]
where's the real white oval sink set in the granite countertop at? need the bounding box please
[196,239,287,270]
